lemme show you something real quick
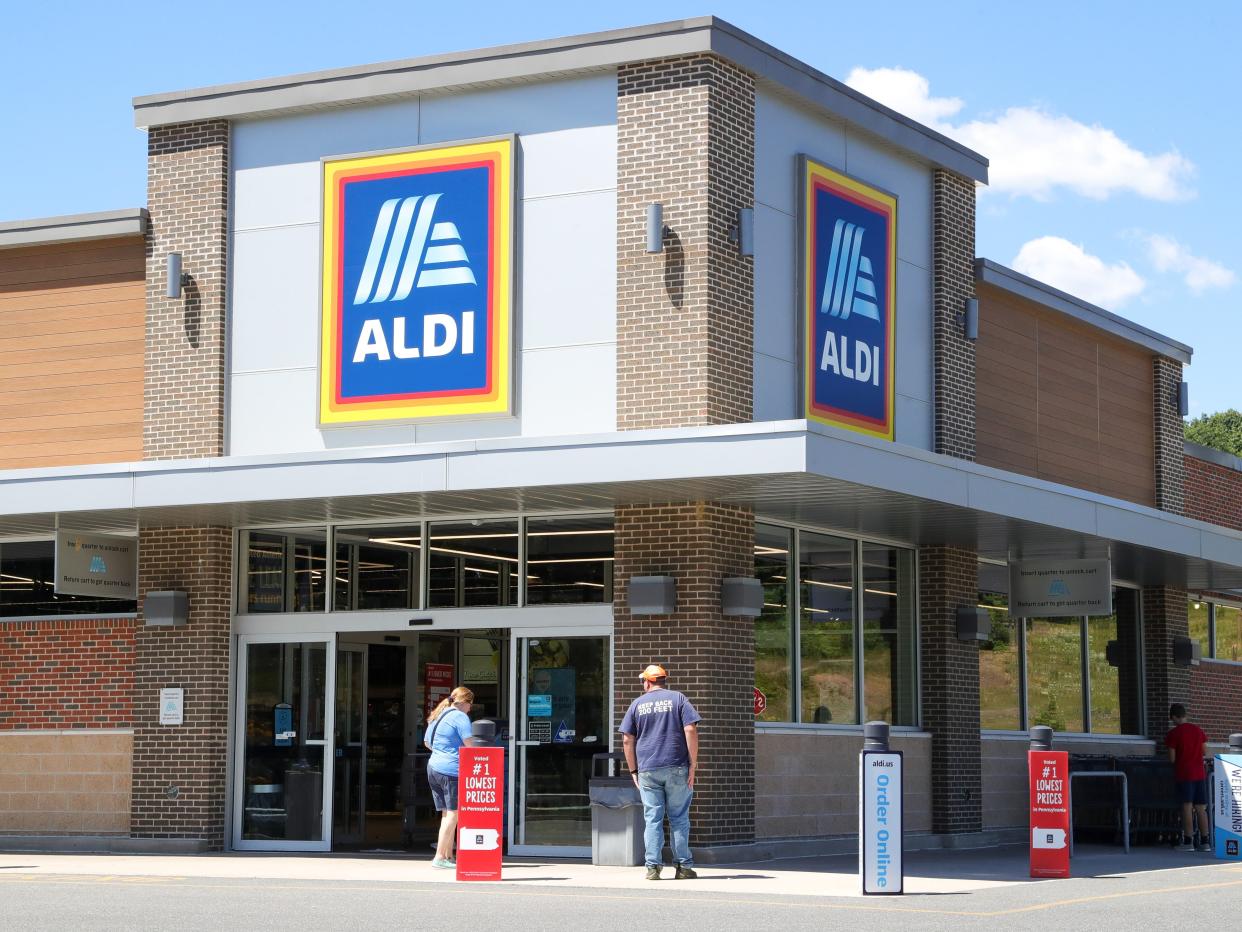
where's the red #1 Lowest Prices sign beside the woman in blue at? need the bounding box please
[457,748,504,880]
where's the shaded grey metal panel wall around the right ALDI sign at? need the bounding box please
[755,89,933,450]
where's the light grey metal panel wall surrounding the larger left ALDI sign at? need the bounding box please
[229,76,616,456]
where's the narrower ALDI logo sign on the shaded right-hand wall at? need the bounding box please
[801,155,897,440]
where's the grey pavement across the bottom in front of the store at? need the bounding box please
[0,846,1242,932]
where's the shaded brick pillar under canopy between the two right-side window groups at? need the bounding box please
[919,547,982,833]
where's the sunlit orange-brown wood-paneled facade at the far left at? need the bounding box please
[0,236,147,470]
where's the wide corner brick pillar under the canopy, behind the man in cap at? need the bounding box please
[612,502,755,846]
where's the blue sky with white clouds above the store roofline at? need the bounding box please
[0,0,1242,414]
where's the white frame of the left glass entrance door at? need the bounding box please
[229,631,337,851]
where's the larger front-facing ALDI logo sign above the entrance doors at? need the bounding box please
[319,137,513,426]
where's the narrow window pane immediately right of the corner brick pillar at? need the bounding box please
[755,524,794,722]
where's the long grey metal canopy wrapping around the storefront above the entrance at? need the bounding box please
[0,421,1242,589]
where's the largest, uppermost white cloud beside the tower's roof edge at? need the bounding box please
[846,68,1195,201]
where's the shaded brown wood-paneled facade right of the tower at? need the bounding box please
[975,282,1155,506]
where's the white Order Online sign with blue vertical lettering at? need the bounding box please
[858,751,904,893]
